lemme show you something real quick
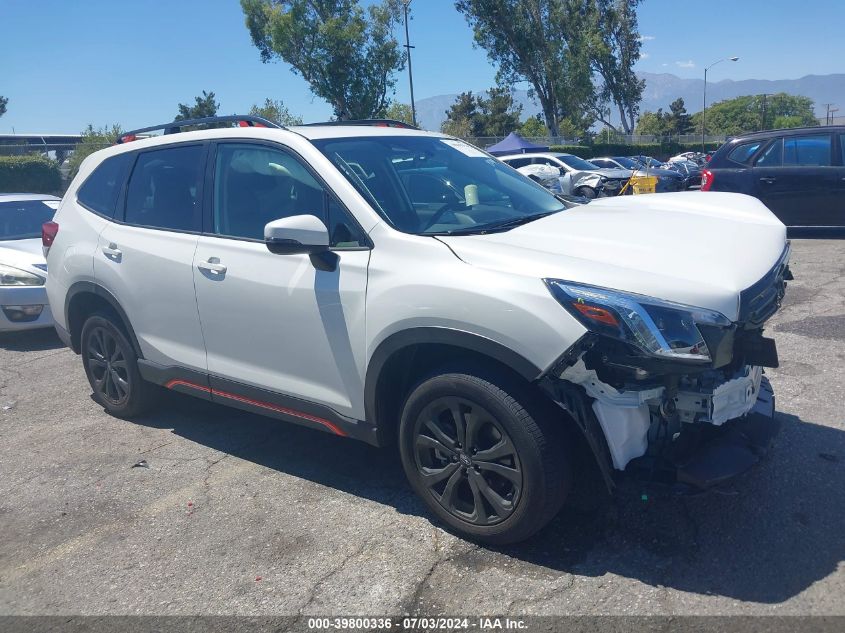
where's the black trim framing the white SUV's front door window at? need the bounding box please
[201,138,375,252]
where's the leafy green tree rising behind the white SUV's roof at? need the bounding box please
[241,0,405,120]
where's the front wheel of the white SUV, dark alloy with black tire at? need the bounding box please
[399,368,570,545]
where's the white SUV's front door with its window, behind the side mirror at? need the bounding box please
[194,142,370,419]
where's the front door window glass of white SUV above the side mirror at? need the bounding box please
[212,143,367,248]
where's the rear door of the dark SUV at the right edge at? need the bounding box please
[751,133,840,226]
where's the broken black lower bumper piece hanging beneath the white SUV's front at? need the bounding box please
[674,378,780,492]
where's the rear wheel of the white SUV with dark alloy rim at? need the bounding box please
[81,313,158,418]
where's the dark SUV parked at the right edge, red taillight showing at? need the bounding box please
[701,126,845,227]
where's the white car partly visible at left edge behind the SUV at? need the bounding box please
[0,193,60,332]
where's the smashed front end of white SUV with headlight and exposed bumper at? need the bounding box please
[541,243,792,493]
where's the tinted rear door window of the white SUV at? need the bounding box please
[124,145,206,231]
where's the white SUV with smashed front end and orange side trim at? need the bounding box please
[45,117,790,543]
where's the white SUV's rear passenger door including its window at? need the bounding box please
[94,143,208,373]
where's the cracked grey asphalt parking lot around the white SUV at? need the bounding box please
[0,240,845,615]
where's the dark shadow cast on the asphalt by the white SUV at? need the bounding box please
[132,393,845,603]
